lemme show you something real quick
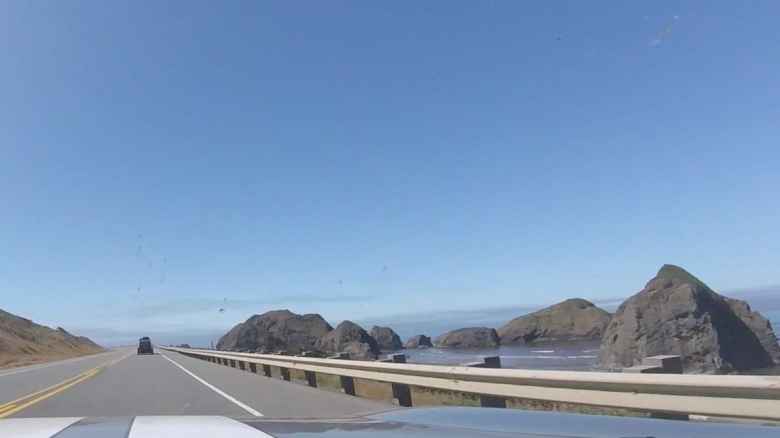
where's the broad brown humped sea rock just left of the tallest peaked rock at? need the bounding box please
[498,298,610,345]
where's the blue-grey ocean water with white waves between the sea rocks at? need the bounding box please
[400,341,599,371]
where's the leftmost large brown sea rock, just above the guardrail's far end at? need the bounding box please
[217,310,333,354]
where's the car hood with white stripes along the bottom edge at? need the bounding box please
[0,407,780,438]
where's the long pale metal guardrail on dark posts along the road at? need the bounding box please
[163,347,780,421]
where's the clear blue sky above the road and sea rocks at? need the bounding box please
[0,1,780,341]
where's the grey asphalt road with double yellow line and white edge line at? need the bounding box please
[0,349,393,418]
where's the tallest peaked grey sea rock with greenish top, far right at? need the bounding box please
[599,265,776,373]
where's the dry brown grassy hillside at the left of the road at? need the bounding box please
[0,310,103,368]
